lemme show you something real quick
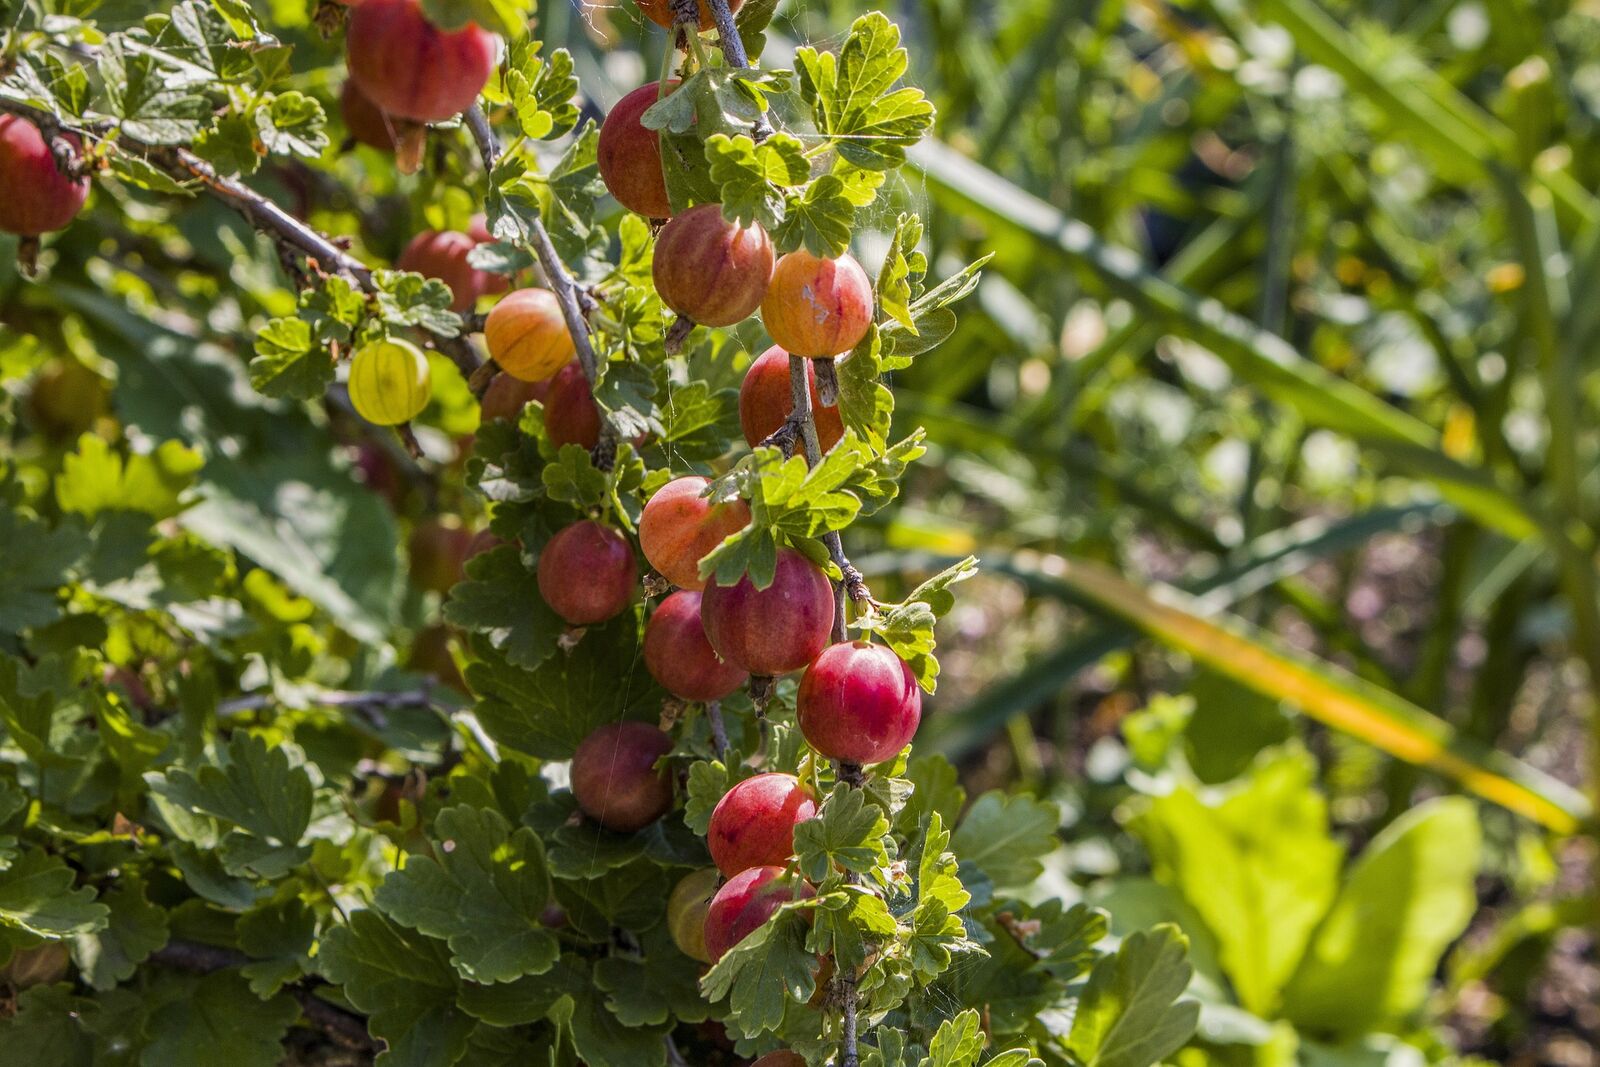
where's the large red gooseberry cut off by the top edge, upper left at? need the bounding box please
[344,0,496,123]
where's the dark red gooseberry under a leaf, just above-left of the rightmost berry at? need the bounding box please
[701,549,834,675]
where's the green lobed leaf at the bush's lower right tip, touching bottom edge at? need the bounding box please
[1067,923,1200,1067]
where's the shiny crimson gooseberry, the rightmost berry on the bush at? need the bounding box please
[795,641,922,763]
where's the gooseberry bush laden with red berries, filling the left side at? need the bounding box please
[0,0,1197,1067]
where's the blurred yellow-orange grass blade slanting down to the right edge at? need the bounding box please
[1058,558,1589,833]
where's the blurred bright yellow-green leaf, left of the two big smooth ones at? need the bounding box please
[1133,750,1344,1017]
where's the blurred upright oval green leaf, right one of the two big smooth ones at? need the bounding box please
[1283,797,1480,1035]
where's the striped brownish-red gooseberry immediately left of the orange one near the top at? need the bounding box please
[651,203,773,326]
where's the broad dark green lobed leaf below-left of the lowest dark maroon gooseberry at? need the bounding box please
[378,805,560,982]
